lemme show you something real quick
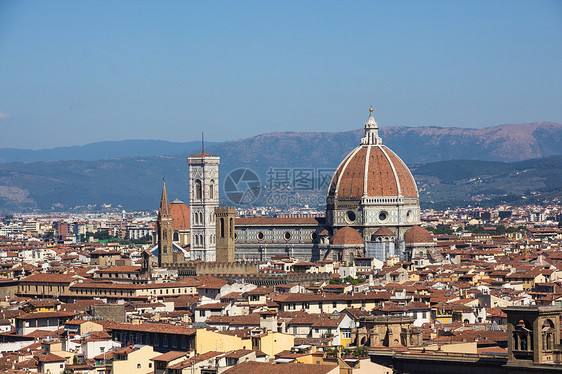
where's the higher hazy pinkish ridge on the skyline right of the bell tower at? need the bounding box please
[201,122,562,167]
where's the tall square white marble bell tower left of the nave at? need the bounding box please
[187,151,220,261]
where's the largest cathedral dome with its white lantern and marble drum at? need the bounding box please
[326,108,420,240]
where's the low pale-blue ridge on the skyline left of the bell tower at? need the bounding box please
[0,140,216,163]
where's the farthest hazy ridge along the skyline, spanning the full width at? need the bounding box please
[0,122,562,167]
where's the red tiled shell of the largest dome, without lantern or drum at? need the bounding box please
[328,144,418,198]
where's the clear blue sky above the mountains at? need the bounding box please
[0,0,562,149]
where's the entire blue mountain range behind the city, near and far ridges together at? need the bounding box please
[0,122,562,212]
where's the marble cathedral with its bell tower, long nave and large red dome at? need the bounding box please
[158,109,431,266]
